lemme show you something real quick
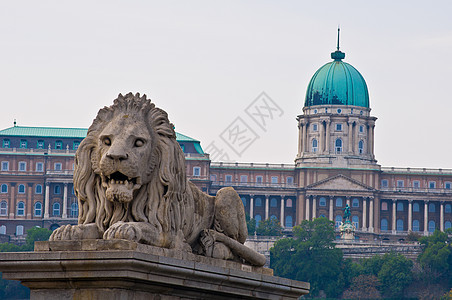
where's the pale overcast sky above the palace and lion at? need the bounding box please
[0,0,452,168]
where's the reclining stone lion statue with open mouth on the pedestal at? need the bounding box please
[50,93,265,266]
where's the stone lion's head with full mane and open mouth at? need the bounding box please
[74,93,187,236]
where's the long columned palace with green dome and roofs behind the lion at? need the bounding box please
[0,38,452,243]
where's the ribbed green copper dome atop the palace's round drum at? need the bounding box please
[304,50,369,108]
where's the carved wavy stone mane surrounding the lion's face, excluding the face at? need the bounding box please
[74,93,193,240]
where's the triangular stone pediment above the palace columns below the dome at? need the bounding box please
[306,174,374,192]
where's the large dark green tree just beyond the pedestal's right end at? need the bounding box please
[270,218,345,297]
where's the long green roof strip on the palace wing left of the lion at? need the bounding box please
[0,126,88,139]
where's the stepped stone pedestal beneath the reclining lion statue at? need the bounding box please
[0,240,309,300]
